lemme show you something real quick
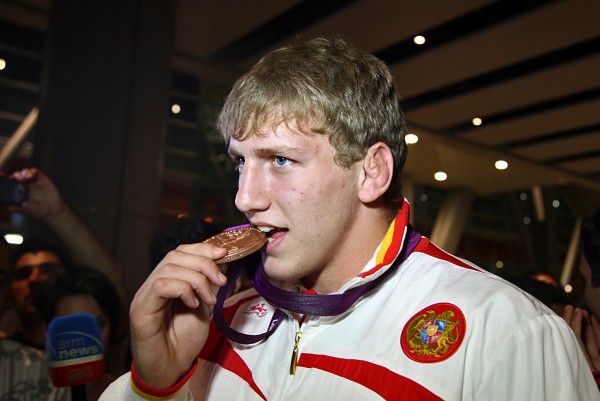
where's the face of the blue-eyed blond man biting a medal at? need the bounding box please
[229,124,362,293]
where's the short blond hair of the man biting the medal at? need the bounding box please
[217,37,406,208]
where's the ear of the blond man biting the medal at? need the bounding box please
[358,142,394,203]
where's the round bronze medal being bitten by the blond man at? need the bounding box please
[204,226,267,264]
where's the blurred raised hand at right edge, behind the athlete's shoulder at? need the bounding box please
[562,305,600,372]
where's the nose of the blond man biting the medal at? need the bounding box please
[235,162,269,214]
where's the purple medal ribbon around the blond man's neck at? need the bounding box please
[213,226,421,344]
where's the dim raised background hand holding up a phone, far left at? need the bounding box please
[9,168,66,219]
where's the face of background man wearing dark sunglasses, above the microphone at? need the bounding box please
[12,251,65,315]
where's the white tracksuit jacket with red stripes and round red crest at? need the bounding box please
[101,203,600,401]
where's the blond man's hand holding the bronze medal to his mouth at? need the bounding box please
[130,243,227,389]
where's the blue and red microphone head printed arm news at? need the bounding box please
[46,313,104,391]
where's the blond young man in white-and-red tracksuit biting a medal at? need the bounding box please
[103,39,600,401]
